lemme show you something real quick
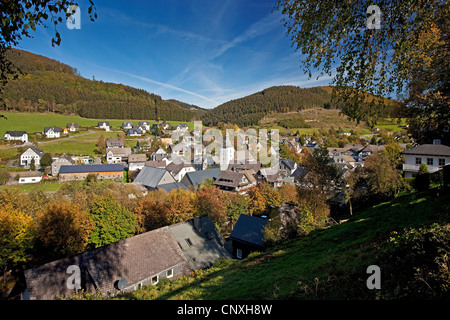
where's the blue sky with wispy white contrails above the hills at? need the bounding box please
[13,0,331,108]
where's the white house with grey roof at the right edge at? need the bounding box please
[402,144,450,178]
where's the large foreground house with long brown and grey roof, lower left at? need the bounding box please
[21,215,231,300]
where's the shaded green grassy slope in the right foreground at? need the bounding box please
[117,189,450,300]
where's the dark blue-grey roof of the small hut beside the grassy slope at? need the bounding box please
[230,214,268,247]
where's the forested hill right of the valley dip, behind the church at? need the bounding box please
[202,86,395,126]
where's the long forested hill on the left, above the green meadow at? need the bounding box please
[2,49,198,121]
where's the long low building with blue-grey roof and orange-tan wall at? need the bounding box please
[59,163,123,182]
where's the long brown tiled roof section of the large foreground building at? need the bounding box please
[24,227,190,300]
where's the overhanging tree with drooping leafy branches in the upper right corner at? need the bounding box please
[276,0,450,134]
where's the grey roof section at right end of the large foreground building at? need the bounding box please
[169,215,231,269]
